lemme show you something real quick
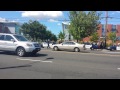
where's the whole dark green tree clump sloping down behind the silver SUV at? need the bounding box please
[20,20,57,41]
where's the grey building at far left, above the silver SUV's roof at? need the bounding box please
[0,21,20,34]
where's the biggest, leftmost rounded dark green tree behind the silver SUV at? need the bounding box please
[21,20,46,41]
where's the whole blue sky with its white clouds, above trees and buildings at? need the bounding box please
[0,11,120,35]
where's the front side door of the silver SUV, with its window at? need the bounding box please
[5,35,16,51]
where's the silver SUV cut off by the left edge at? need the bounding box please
[0,33,41,57]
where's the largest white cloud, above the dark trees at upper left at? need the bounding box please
[19,11,63,19]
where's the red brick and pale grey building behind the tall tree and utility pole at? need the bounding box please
[62,23,120,42]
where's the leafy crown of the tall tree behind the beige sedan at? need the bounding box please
[69,11,100,42]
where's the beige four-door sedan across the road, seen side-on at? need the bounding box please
[52,41,84,52]
